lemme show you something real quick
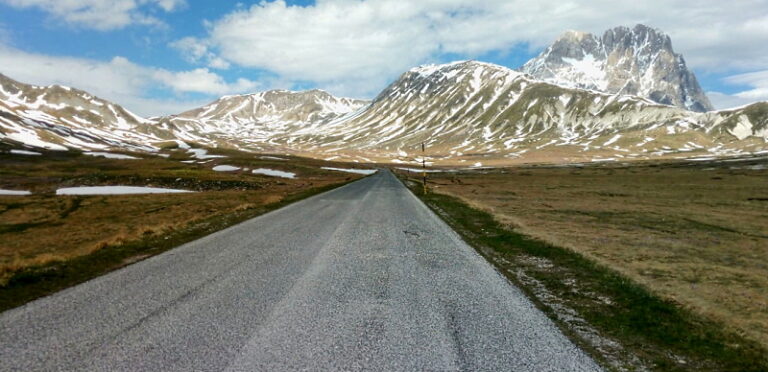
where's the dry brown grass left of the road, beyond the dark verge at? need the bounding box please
[0,151,359,287]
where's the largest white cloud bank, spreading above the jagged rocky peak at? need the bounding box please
[176,0,768,100]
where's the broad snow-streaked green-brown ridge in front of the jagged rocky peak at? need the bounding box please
[289,61,768,164]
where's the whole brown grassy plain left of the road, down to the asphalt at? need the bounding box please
[0,149,360,310]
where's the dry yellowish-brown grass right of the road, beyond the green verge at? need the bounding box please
[420,163,768,346]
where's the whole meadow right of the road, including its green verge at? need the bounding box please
[393,157,768,371]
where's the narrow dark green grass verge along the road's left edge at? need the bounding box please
[0,181,354,312]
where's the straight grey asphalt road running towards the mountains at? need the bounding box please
[0,172,599,371]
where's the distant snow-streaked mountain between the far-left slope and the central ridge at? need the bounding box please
[159,89,368,149]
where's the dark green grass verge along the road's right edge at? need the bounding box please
[406,182,768,371]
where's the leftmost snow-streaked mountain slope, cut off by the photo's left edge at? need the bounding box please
[0,74,172,151]
